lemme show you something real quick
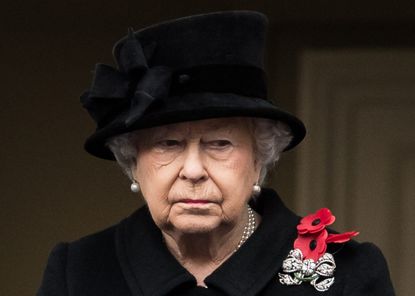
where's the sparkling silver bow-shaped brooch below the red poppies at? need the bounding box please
[278,249,336,292]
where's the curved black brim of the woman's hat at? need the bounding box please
[85,93,306,160]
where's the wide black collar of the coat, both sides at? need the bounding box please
[115,189,299,296]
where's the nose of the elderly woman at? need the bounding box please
[179,143,208,183]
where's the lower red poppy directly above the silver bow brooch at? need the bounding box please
[294,229,328,261]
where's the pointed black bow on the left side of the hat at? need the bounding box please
[81,29,172,128]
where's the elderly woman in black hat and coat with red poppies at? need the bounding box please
[38,11,393,296]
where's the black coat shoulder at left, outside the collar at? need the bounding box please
[37,210,151,296]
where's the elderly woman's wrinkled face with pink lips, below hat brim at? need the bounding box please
[134,118,259,233]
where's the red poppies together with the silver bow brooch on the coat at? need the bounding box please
[278,208,359,292]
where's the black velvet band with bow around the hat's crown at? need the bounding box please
[81,64,266,129]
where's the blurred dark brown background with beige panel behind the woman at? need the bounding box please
[0,0,415,296]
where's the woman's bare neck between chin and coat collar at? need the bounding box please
[163,208,260,286]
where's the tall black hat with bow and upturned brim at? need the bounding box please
[81,11,305,159]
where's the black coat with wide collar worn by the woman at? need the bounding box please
[37,190,394,296]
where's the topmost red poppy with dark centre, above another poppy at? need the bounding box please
[297,208,336,234]
